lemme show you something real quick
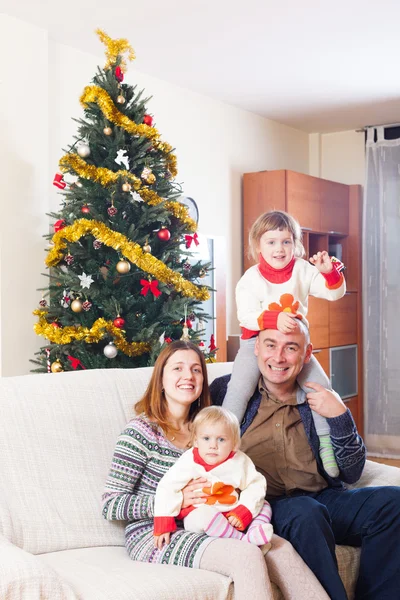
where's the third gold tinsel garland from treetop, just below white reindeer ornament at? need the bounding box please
[60,153,197,231]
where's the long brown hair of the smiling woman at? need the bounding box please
[135,340,211,434]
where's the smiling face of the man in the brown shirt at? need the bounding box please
[254,327,312,386]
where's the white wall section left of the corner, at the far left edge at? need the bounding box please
[0,15,48,375]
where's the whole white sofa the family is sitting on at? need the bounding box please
[0,363,400,600]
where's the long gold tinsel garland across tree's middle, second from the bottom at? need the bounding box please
[46,219,210,301]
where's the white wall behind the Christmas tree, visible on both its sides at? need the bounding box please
[0,16,309,375]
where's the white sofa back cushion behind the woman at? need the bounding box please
[0,363,231,554]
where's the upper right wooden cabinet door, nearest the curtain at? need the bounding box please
[320,179,349,233]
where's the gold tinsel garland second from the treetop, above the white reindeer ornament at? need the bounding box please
[80,85,178,177]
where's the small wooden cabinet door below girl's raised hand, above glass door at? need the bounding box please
[329,293,358,346]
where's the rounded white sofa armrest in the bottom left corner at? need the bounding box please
[0,536,78,600]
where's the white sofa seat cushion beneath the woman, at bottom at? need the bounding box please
[37,547,233,600]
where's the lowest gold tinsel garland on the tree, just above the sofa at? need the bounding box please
[33,310,151,356]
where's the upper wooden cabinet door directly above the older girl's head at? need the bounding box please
[286,171,322,231]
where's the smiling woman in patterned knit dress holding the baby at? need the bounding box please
[103,340,273,600]
